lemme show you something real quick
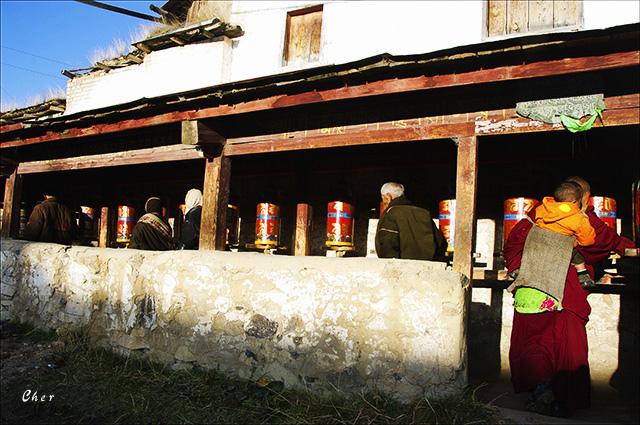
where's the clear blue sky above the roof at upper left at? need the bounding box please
[0,0,165,111]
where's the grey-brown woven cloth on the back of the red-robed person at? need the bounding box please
[507,225,575,301]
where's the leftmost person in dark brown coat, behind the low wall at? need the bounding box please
[24,195,77,245]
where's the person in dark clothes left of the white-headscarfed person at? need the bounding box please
[129,197,177,251]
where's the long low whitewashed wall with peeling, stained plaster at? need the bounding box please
[1,240,468,400]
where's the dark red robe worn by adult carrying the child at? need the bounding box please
[504,207,634,411]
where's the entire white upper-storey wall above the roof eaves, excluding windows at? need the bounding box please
[66,0,640,114]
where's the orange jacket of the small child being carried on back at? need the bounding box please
[536,197,596,246]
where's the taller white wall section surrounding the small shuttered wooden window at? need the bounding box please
[231,1,482,80]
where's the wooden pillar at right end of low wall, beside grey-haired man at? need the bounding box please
[453,136,478,282]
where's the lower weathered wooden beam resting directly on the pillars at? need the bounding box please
[7,93,640,165]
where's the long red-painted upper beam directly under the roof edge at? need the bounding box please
[0,51,640,148]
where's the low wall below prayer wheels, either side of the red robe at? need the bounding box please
[467,282,640,400]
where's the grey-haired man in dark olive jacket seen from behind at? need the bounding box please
[376,182,447,260]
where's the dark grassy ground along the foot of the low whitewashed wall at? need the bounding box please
[0,322,510,425]
